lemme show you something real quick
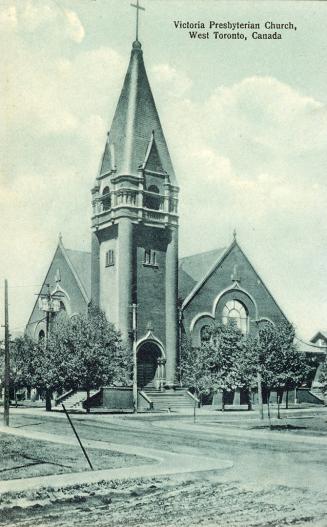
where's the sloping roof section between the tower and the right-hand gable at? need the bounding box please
[178,248,225,300]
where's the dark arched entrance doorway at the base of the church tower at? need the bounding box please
[137,341,161,388]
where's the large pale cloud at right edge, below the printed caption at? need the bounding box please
[206,76,327,156]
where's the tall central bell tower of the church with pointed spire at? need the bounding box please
[91,35,179,386]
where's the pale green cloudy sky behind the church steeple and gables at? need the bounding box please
[0,0,327,339]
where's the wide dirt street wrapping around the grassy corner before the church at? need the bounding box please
[0,410,327,527]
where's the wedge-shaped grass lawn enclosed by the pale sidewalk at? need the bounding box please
[0,434,151,480]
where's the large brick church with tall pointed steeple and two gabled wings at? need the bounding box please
[27,26,320,410]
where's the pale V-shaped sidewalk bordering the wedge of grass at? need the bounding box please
[0,427,233,495]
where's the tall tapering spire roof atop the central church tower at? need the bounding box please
[99,41,176,184]
